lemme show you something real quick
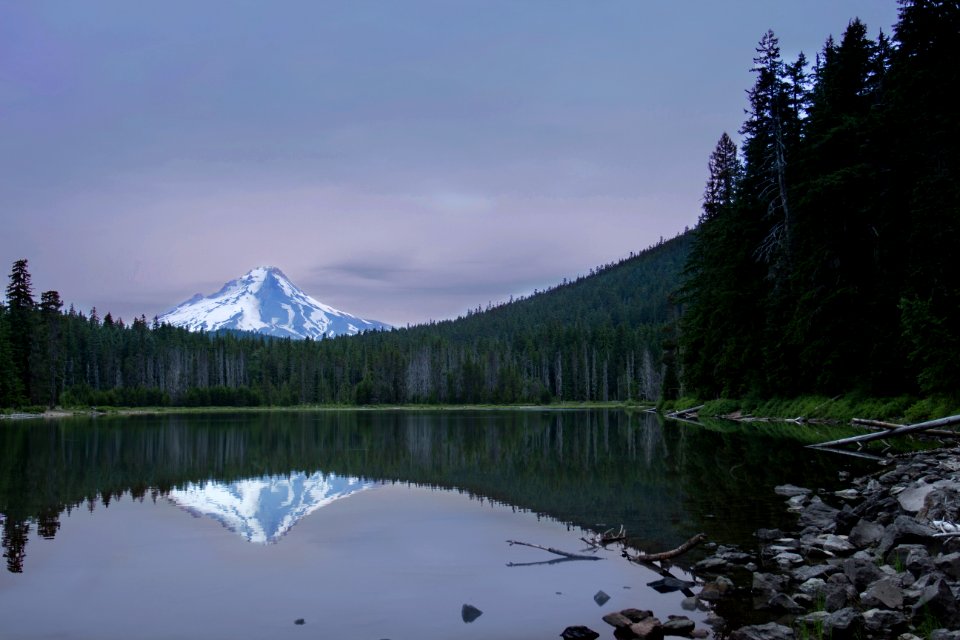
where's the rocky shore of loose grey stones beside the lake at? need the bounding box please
[562,447,960,640]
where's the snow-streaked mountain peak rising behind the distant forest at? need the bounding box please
[157,267,391,339]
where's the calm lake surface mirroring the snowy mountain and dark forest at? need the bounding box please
[0,410,872,640]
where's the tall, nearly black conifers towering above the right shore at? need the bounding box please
[680,0,960,398]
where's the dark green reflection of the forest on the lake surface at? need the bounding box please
[0,411,872,571]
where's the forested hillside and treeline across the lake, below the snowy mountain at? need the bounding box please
[0,234,690,407]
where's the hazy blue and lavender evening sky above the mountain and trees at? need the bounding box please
[0,0,897,325]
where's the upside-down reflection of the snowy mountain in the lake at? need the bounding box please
[167,471,374,544]
